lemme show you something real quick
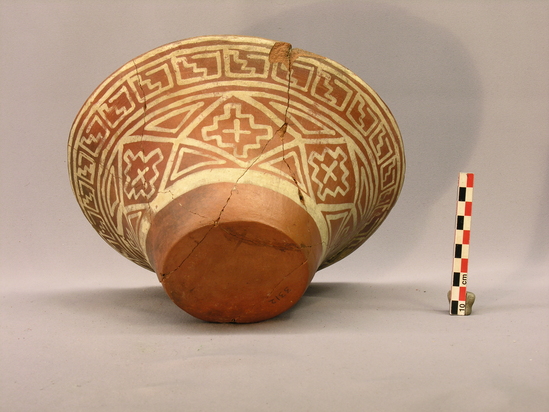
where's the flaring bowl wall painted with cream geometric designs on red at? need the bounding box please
[68,36,402,269]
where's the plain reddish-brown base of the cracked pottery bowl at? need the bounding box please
[147,183,322,323]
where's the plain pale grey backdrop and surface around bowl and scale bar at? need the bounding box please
[0,0,549,411]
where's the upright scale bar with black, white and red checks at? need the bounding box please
[450,173,474,316]
